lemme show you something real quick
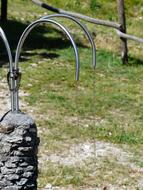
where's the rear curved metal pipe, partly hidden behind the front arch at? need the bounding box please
[41,14,96,69]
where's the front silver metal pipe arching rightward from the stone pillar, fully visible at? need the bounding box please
[13,19,80,112]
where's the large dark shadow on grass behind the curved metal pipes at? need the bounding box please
[0,20,85,67]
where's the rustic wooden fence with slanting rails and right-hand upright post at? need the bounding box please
[32,0,143,64]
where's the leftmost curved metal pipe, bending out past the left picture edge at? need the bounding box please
[0,27,14,111]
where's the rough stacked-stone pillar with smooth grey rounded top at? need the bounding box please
[0,112,39,190]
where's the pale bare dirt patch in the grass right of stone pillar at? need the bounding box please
[41,141,143,170]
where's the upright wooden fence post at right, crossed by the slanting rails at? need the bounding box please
[117,0,128,64]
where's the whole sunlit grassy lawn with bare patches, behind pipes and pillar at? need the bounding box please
[0,0,143,190]
